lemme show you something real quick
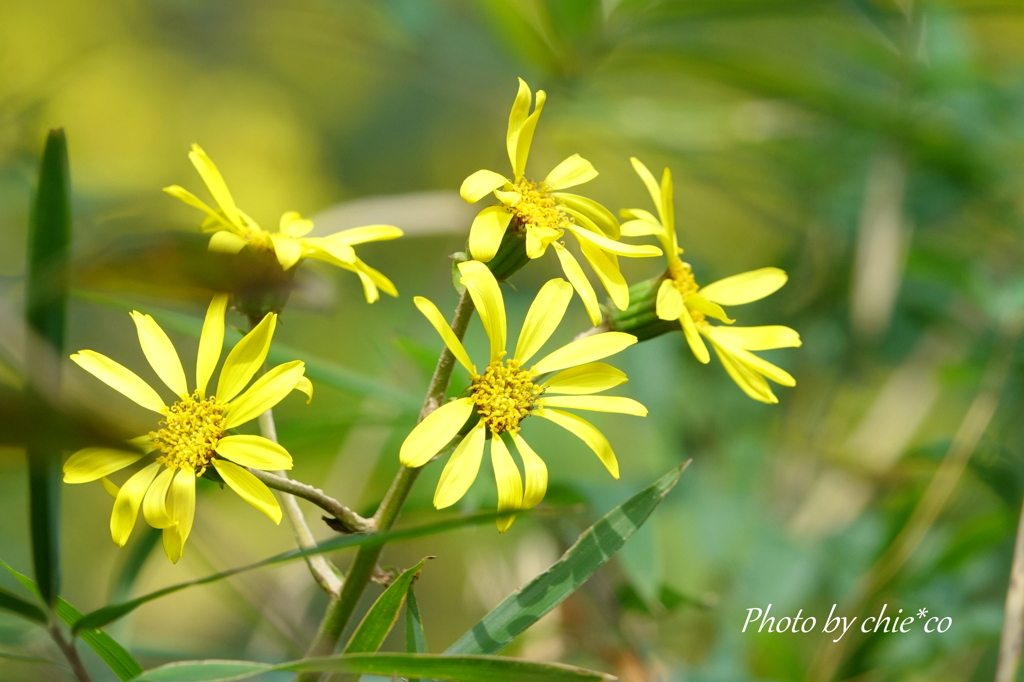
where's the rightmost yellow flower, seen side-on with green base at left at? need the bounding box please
[622,158,801,402]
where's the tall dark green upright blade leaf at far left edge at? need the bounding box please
[25,128,71,606]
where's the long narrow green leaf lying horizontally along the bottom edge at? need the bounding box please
[137,653,615,682]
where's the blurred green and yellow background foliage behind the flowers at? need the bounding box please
[0,0,1024,682]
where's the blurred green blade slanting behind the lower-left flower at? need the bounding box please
[72,290,422,413]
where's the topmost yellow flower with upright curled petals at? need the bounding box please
[460,78,662,327]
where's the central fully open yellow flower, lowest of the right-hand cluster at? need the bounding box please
[399,260,647,532]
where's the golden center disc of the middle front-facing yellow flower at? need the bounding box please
[470,359,544,433]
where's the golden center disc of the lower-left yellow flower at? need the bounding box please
[150,391,227,476]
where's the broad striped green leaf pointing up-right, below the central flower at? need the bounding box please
[445,462,689,653]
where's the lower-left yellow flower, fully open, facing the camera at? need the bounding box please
[63,295,312,563]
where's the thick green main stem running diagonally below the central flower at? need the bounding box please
[295,292,473,682]
